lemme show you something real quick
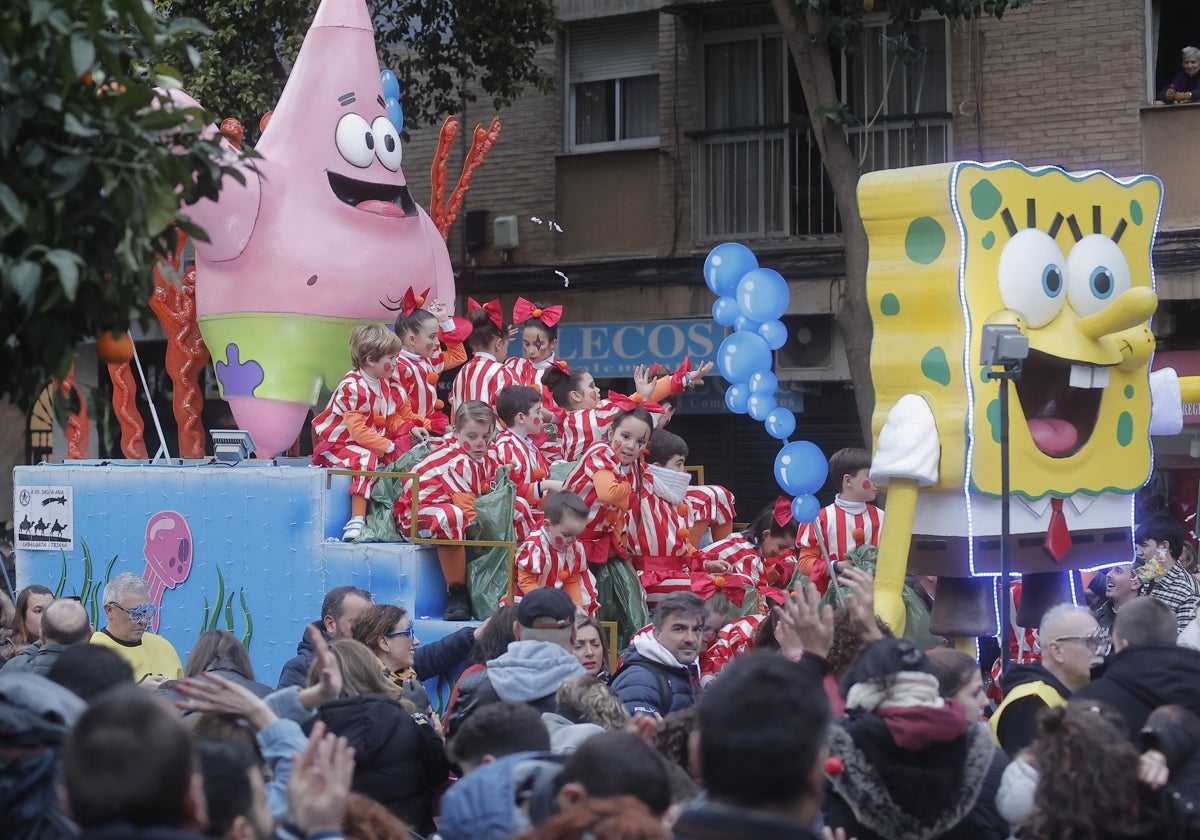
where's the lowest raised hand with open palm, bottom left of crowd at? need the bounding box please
[287,720,354,835]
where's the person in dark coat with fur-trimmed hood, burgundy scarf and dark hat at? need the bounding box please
[822,638,1008,840]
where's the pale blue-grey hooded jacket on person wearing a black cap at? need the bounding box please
[446,640,587,732]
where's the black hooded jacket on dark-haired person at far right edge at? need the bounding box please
[1075,644,1200,734]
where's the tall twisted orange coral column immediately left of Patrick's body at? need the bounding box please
[150,233,211,458]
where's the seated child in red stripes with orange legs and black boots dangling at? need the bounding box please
[394,401,496,622]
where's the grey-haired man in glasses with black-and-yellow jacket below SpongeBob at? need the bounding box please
[989,604,1109,757]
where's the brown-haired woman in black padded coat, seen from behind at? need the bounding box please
[308,638,450,835]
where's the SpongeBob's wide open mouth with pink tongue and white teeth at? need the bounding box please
[1016,350,1109,458]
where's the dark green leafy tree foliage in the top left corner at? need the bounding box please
[0,0,234,407]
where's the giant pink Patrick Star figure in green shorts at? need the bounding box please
[174,0,455,457]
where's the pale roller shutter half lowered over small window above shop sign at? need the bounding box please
[566,14,659,84]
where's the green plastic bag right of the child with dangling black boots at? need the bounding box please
[467,467,517,618]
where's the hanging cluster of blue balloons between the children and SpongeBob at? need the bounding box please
[704,242,828,522]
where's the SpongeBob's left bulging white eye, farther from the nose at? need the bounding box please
[1000,228,1067,328]
